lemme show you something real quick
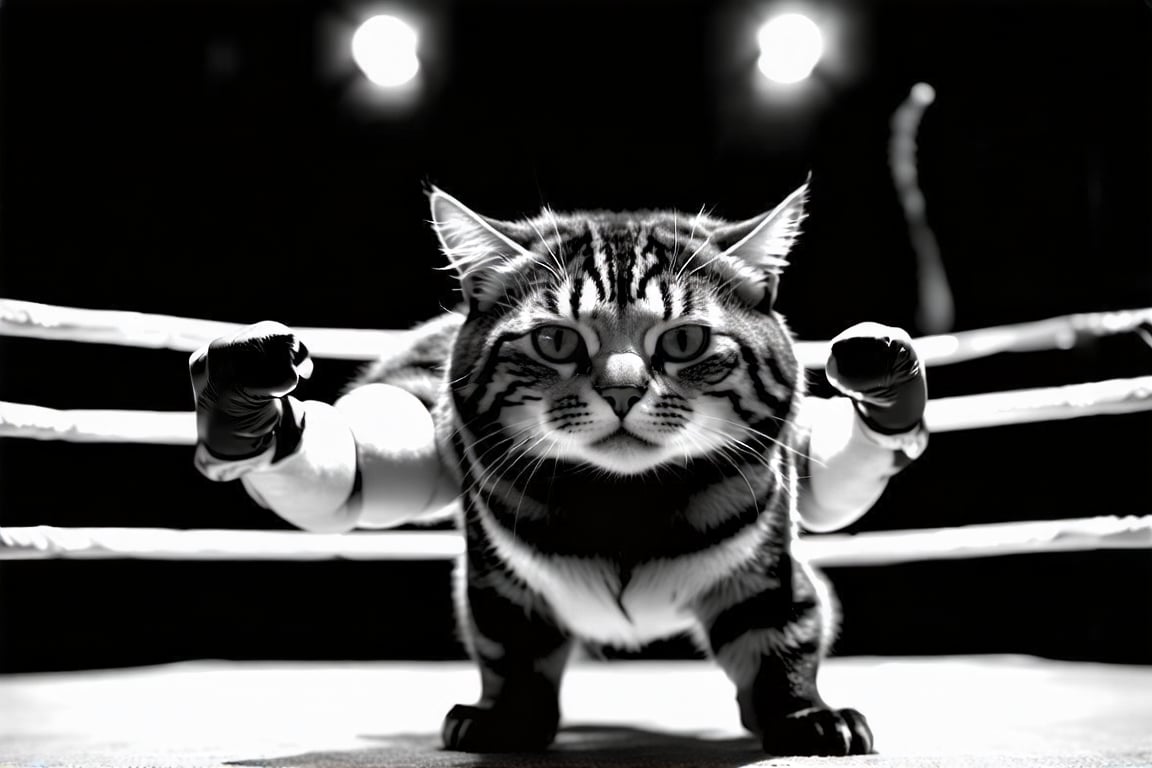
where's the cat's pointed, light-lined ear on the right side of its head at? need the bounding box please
[712,181,808,309]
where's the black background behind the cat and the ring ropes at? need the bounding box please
[0,0,1152,671]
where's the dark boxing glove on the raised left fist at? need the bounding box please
[188,320,312,461]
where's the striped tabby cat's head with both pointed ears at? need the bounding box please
[431,184,806,476]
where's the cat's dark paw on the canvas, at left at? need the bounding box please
[441,704,560,752]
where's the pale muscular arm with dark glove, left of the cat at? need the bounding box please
[188,320,456,533]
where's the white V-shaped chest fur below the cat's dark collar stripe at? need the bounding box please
[482,515,763,647]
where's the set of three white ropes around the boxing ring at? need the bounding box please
[0,299,1152,565]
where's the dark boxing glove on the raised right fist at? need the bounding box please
[825,322,927,434]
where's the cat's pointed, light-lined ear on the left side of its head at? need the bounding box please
[429,187,532,310]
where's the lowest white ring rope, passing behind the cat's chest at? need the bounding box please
[0,516,1152,567]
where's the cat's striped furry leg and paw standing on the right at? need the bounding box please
[697,555,872,755]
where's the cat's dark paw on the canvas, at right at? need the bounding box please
[761,707,872,755]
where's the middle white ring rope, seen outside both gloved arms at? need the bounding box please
[0,377,1152,446]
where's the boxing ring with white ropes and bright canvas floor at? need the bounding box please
[0,301,1152,767]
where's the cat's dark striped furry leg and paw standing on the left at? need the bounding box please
[442,553,571,752]
